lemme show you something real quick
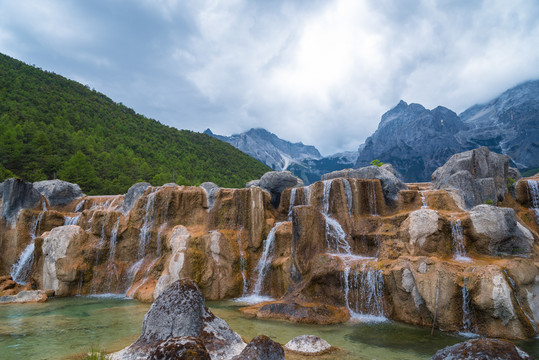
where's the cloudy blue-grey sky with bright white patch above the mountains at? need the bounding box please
[0,0,539,155]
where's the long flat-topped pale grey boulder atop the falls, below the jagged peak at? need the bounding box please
[322,164,408,203]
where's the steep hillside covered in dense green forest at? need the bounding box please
[0,54,270,195]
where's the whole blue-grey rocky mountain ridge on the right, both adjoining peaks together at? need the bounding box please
[355,80,539,182]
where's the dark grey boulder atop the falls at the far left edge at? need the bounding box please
[2,178,41,224]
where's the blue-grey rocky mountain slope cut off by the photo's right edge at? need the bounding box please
[458,80,539,169]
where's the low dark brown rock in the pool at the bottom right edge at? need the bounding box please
[430,339,533,360]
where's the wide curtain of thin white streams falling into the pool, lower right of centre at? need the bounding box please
[341,258,387,322]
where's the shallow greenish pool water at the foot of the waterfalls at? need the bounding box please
[0,297,539,360]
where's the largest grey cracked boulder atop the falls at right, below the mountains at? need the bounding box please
[432,147,515,209]
